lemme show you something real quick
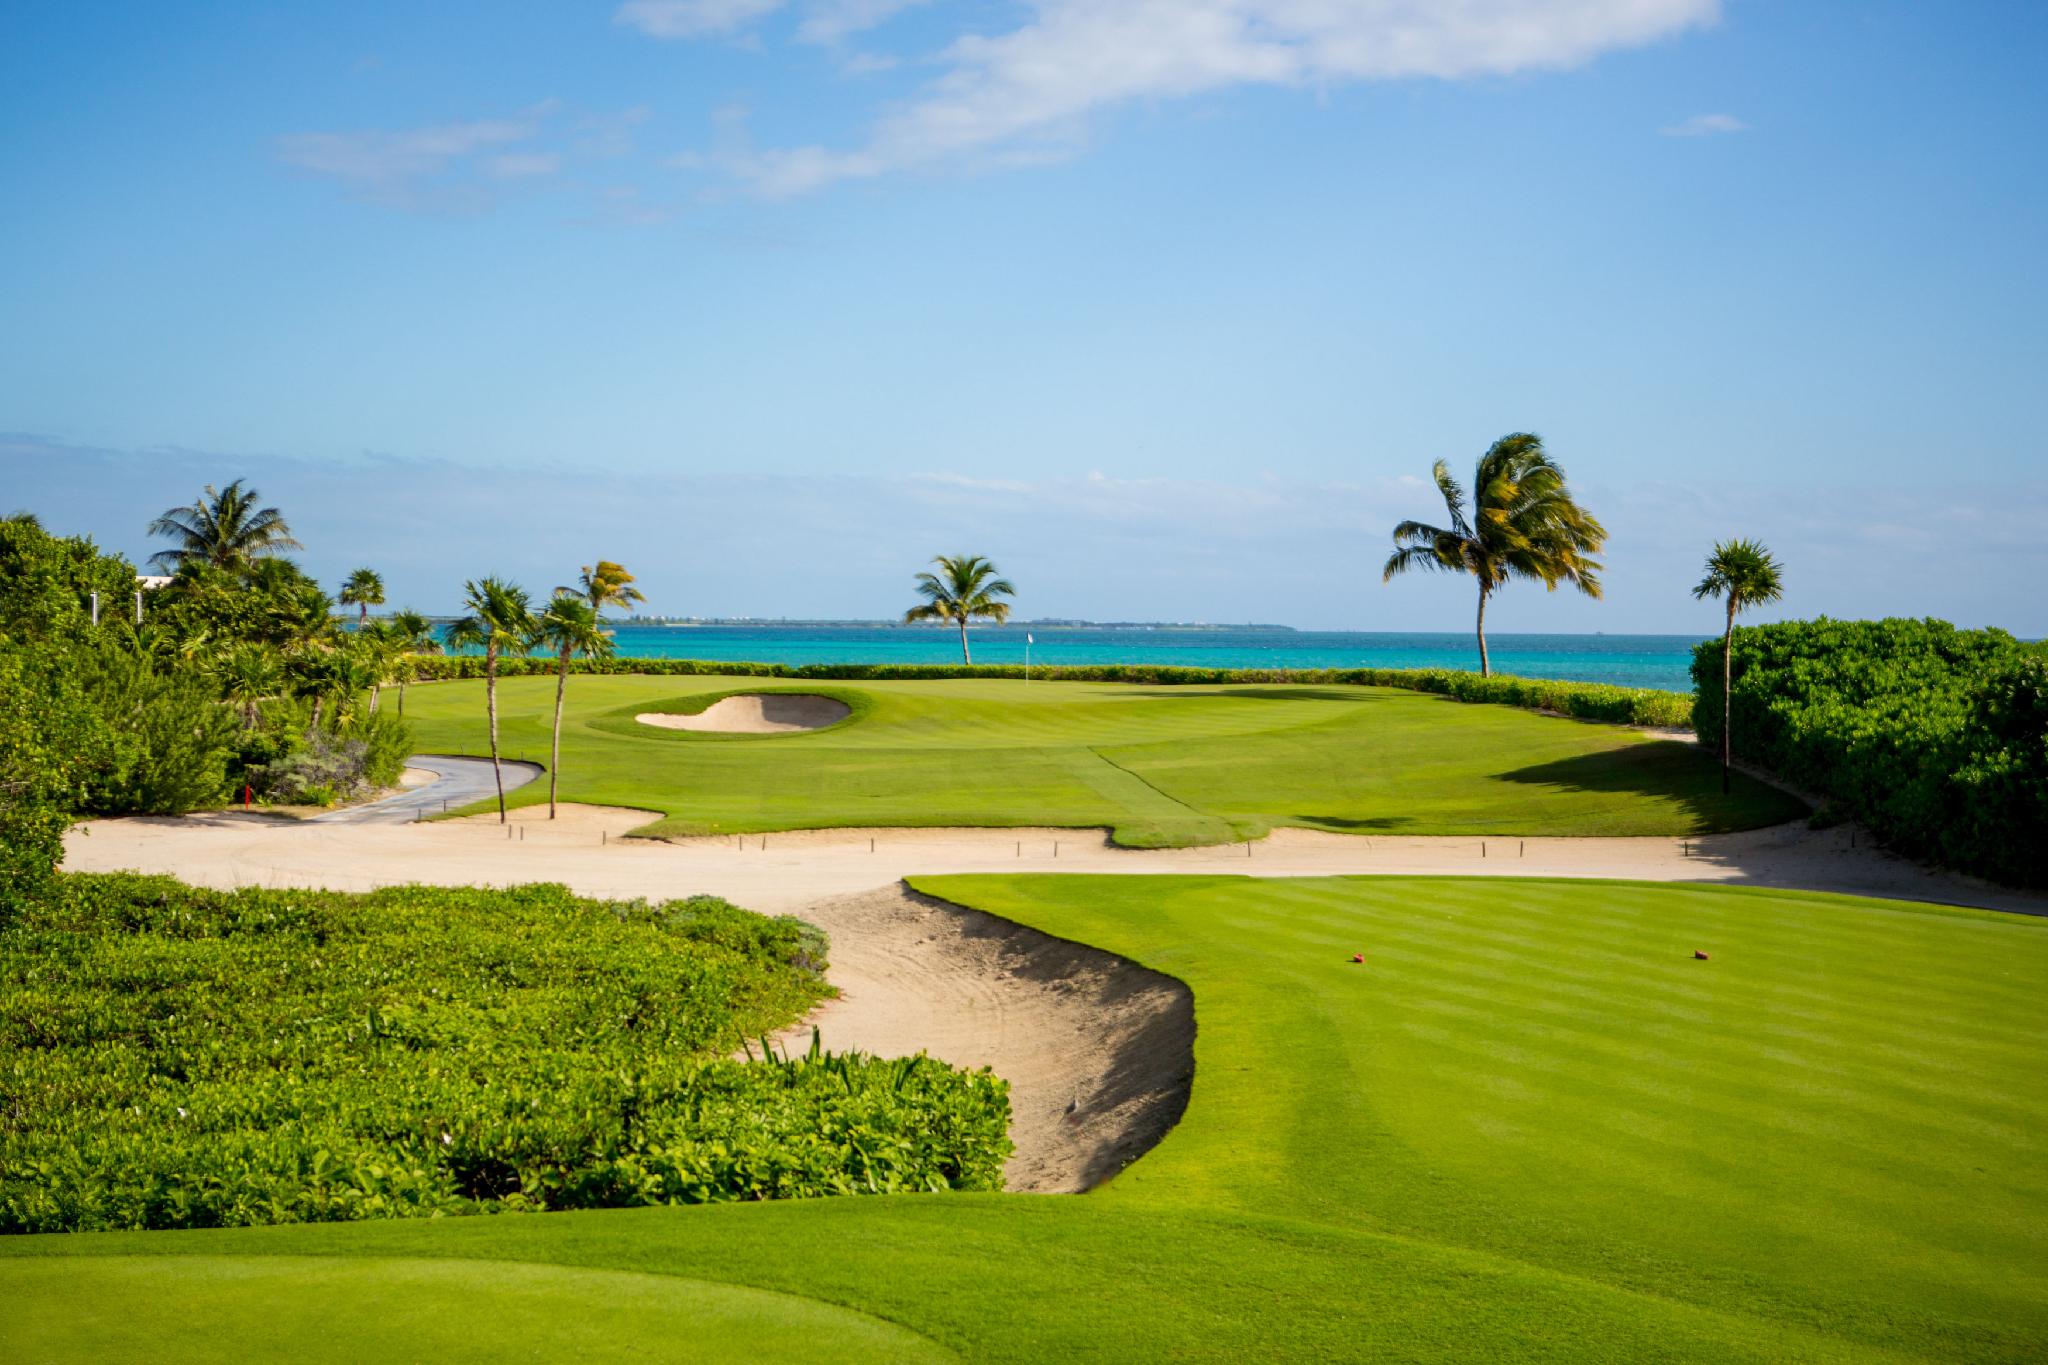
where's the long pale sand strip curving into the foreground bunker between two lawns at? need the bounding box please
[66,806,2048,1191]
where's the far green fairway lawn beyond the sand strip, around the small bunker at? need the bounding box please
[395,677,1802,847]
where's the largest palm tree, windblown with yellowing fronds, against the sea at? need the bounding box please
[1380,432,1608,677]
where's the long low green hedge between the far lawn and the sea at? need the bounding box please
[414,655,1692,729]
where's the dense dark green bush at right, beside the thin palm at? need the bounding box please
[1692,618,2048,886]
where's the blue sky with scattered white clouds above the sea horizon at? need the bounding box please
[0,0,2048,634]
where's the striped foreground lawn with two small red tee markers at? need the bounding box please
[0,876,2048,1361]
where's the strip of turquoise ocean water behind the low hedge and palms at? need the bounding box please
[569,624,1700,692]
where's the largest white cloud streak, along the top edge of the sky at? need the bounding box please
[663,0,1718,196]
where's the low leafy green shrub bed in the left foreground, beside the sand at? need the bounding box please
[0,876,1010,1232]
